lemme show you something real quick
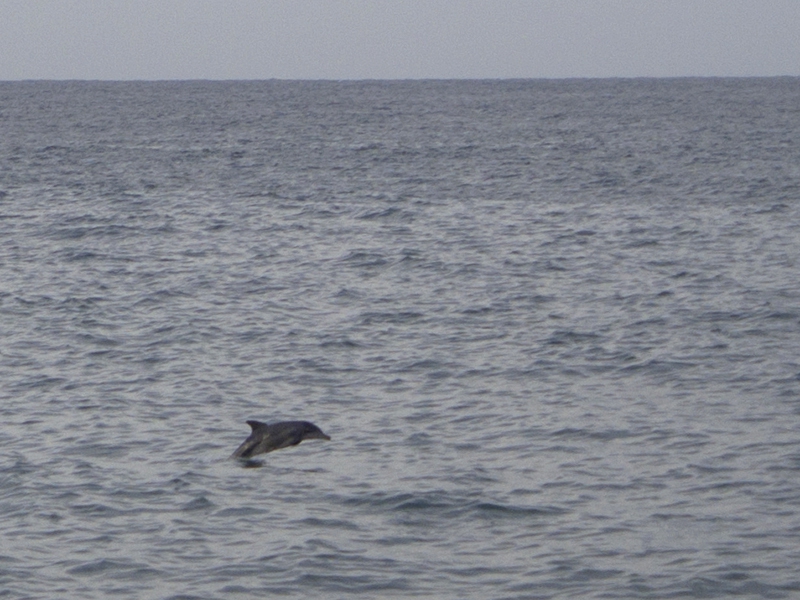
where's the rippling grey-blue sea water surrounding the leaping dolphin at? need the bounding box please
[0,79,800,599]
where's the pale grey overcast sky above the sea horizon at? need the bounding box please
[0,0,800,80]
